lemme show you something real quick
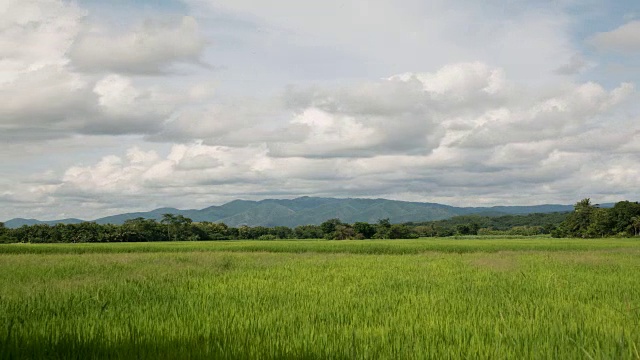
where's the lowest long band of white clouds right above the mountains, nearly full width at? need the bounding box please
[18,127,640,217]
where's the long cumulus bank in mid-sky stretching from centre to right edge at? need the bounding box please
[260,63,635,157]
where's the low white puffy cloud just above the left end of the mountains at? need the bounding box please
[59,144,264,194]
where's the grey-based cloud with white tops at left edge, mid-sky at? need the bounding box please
[0,69,182,141]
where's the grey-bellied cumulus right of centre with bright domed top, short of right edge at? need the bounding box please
[270,63,508,157]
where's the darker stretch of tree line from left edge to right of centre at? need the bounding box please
[0,214,417,243]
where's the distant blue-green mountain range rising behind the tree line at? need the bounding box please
[0,196,580,228]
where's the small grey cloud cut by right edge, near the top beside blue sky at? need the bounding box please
[588,20,640,53]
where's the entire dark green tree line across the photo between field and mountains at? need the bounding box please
[0,199,640,243]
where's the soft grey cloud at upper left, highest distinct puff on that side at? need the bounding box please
[69,16,206,74]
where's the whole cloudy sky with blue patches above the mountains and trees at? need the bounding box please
[0,0,640,221]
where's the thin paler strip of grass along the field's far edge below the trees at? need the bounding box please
[0,237,640,254]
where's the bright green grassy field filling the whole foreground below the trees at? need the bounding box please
[0,238,640,359]
